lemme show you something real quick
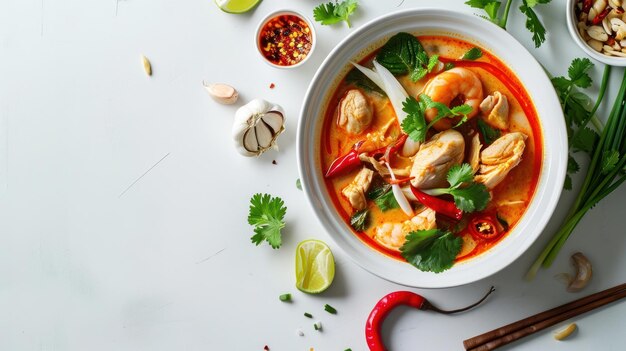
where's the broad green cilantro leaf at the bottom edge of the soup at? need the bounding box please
[400,229,463,273]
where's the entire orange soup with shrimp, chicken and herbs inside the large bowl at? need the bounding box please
[321,33,542,272]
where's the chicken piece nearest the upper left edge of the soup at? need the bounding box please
[337,89,374,134]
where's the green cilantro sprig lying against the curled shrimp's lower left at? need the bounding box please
[401,94,472,142]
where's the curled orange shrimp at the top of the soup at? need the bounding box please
[423,67,483,131]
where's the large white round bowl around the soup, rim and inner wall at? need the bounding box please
[297,9,567,288]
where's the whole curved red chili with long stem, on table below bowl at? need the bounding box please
[365,286,496,351]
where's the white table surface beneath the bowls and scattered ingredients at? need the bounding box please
[0,0,626,351]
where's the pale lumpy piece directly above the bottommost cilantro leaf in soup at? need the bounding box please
[374,207,437,251]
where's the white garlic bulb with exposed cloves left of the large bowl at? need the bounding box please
[232,99,285,156]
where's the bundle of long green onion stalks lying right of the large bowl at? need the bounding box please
[526,66,626,280]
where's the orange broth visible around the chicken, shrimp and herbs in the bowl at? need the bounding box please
[320,36,543,262]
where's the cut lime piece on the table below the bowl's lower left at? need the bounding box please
[296,239,335,294]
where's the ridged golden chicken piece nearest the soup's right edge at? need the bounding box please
[474,132,527,189]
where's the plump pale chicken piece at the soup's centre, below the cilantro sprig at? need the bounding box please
[411,129,465,189]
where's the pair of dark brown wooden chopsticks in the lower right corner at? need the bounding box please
[463,283,626,351]
